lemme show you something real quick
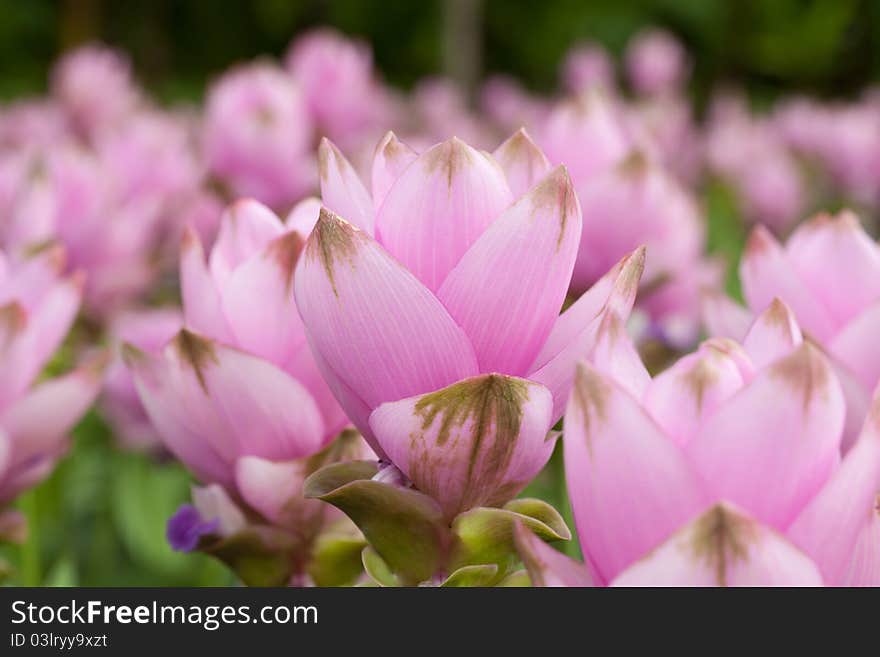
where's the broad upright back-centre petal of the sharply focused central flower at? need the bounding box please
[376,137,513,290]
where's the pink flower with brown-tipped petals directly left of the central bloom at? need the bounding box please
[124,200,346,492]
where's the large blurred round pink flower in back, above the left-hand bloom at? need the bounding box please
[203,62,315,208]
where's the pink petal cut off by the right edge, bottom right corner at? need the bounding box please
[787,397,880,586]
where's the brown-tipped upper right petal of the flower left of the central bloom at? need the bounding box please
[220,232,306,364]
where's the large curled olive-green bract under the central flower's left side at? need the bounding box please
[304,461,451,585]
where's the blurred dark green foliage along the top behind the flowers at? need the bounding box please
[0,0,880,98]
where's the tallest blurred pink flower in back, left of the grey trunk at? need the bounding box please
[286,28,388,148]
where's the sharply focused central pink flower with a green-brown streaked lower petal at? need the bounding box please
[294,131,644,518]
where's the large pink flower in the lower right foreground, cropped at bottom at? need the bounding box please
[521,300,880,586]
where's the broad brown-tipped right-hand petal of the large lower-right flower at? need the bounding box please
[686,342,844,529]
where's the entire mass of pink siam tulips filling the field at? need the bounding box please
[0,30,880,586]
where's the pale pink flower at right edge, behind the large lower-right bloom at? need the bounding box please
[704,211,880,447]
